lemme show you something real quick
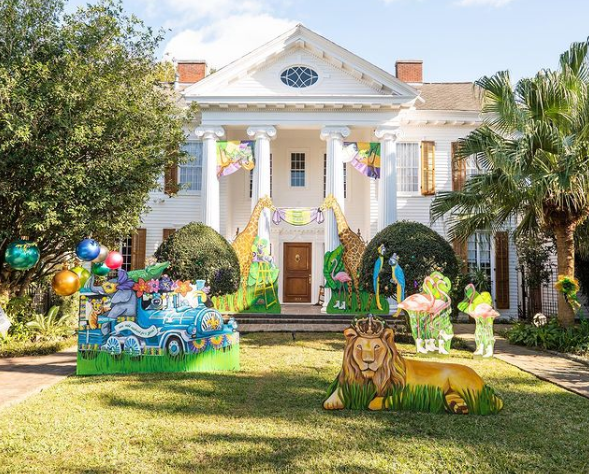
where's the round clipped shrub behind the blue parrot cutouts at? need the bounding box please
[360,221,460,297]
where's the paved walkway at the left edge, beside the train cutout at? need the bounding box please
[0,346,76,409]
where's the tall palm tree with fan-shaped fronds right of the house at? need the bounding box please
[431,40,589,325]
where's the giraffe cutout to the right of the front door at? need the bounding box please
[320,194,366,311]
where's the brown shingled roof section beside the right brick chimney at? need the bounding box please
[414,82,481,112]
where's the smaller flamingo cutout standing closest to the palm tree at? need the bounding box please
[458,283,499,357]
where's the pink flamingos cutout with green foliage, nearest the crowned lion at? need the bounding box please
[399,272,454,355]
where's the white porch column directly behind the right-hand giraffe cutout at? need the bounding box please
[321,126,350,309]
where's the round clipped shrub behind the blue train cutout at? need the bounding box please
[154,222,240,296]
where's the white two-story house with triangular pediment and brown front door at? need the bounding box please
[130,25,518,317]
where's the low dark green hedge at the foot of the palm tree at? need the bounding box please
[507,319,589,354]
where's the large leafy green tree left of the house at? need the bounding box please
[0,0,189,295]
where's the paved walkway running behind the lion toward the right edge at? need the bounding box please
[454,324,589,398]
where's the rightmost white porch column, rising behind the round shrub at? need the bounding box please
[374,127,400,231]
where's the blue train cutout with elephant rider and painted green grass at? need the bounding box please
[77,264,239,375]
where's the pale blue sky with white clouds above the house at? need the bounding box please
[68,0,589,82]
